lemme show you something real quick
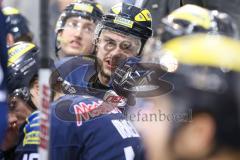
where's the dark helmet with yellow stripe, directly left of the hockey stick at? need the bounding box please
[7,42,39,93]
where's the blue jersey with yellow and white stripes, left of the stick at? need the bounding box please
[15,111,40,160]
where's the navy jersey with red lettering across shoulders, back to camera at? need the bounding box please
[50,95,144,160]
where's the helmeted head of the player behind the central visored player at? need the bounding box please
[55,1,103,58]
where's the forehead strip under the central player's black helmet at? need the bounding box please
[100,29,141,43]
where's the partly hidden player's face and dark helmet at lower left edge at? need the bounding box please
[0,88,36,160]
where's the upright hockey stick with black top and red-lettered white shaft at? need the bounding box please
[39,0,51,160]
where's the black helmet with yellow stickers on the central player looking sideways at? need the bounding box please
[95,3,152,52]
